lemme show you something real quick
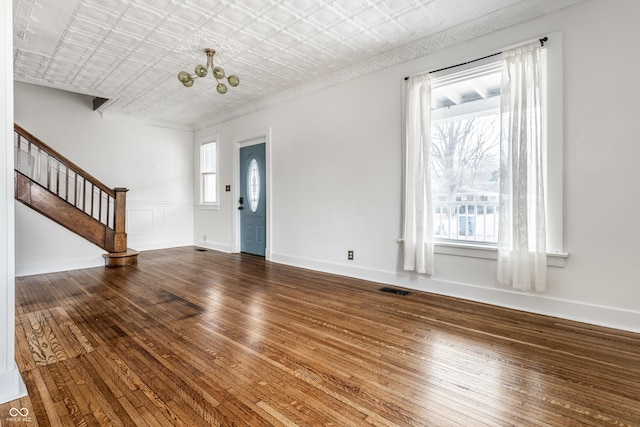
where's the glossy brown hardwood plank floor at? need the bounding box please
[0,248,640,427]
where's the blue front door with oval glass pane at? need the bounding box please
[238,143,267,256]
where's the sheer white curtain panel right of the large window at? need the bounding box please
[498,42,547,291]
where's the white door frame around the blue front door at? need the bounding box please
[231,127,273,261]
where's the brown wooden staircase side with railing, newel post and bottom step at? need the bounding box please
[13,124,138,267]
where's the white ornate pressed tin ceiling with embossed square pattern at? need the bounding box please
[13,0,584,129]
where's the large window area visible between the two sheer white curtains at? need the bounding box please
[431,56,501,244]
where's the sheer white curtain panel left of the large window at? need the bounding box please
[404,74,434,274]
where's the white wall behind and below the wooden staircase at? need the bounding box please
[15,83,193,276]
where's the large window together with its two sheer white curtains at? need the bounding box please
[403,33,566,280]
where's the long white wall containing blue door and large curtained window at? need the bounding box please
[194,0,640,332]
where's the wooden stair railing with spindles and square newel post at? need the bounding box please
[13,124,128,252]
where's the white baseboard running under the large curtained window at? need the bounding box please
[271,253,640,333]
